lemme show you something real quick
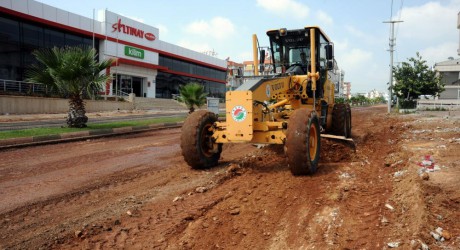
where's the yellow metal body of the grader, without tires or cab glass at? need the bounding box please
[212,27,334,144]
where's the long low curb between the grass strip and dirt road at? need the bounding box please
[0,122,184,150]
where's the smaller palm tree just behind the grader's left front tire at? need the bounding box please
[178,82,208,114]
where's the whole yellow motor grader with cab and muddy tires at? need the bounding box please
[181,26,351,175]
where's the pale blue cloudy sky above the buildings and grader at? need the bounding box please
[38,0,460,93]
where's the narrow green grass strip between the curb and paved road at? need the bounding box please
[0,116,185,140]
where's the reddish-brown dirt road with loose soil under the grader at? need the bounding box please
[0,106,460,249]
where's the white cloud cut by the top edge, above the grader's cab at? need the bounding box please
[257,0,310,20]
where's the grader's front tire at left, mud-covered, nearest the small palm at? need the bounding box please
[180,110,222,169]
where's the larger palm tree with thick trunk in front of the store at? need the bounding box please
[27,46,112,128]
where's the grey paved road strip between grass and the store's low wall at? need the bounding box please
[0,111,187,131]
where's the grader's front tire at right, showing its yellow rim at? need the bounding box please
[285,109,321,175]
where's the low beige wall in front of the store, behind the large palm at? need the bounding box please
[0,96,133,115]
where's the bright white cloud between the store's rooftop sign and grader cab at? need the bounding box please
[185,17,235,40]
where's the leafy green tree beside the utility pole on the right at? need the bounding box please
[393,52,444,100]
